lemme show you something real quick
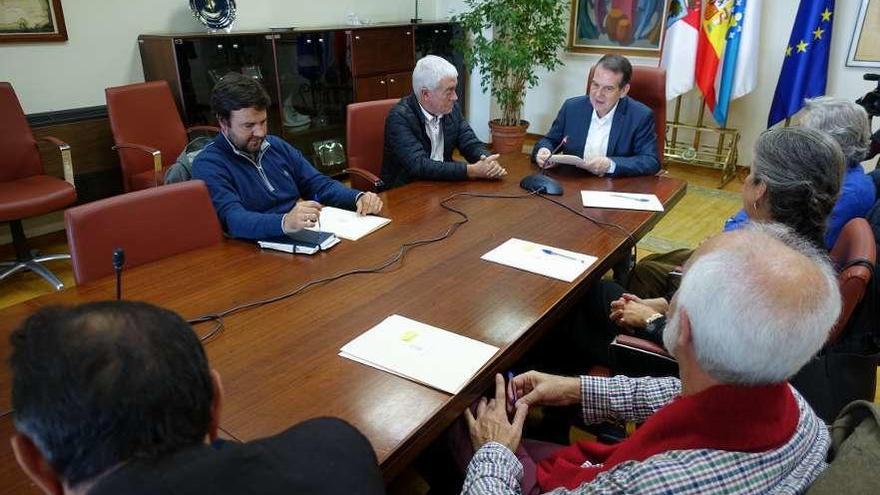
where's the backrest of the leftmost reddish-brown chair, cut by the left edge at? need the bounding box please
[0,82,43,182]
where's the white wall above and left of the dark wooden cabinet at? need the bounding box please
[0,0,436,113]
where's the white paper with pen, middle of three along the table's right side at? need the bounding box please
[481,238,596,282]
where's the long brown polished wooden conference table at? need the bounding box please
[0,154,685,494]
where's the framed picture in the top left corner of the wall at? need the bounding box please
[0,0,67,43]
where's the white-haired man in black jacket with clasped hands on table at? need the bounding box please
[382,55,507,187]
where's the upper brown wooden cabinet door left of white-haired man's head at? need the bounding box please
[349,26,415,76]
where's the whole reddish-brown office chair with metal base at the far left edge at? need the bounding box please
[0,82,76,290]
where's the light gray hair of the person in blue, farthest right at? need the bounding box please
[800,96,871,165]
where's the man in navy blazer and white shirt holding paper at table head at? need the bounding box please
[532,55,660,176]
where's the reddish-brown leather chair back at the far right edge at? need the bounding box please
[828,218,877,344]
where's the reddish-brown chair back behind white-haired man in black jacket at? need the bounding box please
[345,98,399,191]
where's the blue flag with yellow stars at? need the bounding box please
[767,0,834,127]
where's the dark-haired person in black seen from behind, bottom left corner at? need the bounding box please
[9,301,384,495]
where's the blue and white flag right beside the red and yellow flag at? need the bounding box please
[712,0,761,126]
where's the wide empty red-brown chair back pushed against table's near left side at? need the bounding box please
[64,180,223,284]
